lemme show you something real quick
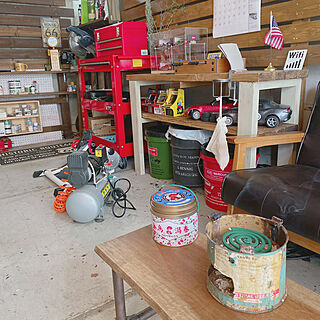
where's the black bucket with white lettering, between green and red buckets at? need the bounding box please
[171,136,203,187]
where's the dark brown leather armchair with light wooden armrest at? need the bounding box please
[222,82,320,246]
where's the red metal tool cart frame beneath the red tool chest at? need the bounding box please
[78,55,150,157]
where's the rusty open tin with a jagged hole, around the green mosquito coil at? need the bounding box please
[206,214,288,313]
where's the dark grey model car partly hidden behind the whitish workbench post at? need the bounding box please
[223,99,292,128]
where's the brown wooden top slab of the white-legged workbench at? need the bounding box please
[127,69,308,82]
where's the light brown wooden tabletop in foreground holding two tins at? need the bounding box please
[95,226,320,320]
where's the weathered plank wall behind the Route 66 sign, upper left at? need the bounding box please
[0,0,74,70]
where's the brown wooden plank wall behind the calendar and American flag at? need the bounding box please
[121,0,320,68]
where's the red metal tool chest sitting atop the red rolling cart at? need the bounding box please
[94,21,148,57]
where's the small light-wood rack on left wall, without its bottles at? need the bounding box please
[0,100,43,137]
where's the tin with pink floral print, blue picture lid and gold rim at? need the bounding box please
[151,188,198,247]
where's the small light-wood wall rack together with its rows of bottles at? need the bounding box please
[0,100,43,137]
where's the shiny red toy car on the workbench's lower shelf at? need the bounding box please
[185,97,238,120]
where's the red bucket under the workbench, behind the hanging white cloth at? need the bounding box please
[200,144,234,212]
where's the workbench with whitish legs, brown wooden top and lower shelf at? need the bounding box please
[127,69,308,175]
